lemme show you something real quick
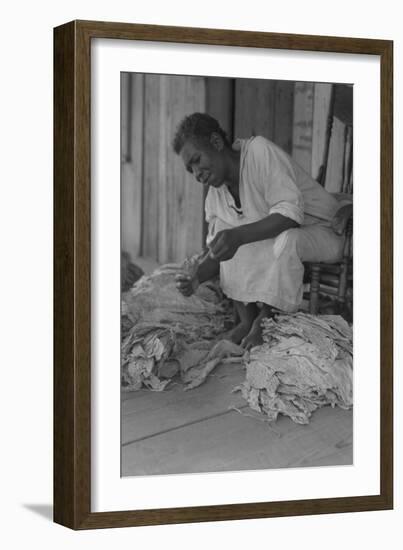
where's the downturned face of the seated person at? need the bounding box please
[180,136,225,187]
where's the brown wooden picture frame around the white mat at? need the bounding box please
[54,21,393,529]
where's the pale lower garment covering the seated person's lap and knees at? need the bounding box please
[216,220,344,312]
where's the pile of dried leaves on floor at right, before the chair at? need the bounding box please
[236,313,353,424]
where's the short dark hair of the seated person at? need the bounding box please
[172,113,230,155]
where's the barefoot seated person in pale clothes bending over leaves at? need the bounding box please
[173,113,343,348]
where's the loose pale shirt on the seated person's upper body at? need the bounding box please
[205,136,340,242]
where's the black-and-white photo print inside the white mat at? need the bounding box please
[121,73,353,476]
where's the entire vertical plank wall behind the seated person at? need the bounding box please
[121,74,352,263]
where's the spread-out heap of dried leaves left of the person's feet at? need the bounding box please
[121,258,243,391]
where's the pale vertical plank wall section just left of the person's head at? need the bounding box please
[142,75,206,263]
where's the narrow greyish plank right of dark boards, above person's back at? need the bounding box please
[292,82,314,174]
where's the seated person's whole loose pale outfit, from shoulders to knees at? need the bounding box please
[205,137,342,311]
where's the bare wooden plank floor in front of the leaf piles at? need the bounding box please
[122,364,353,476]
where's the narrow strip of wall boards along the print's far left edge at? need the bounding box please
[121,73,144,257]
